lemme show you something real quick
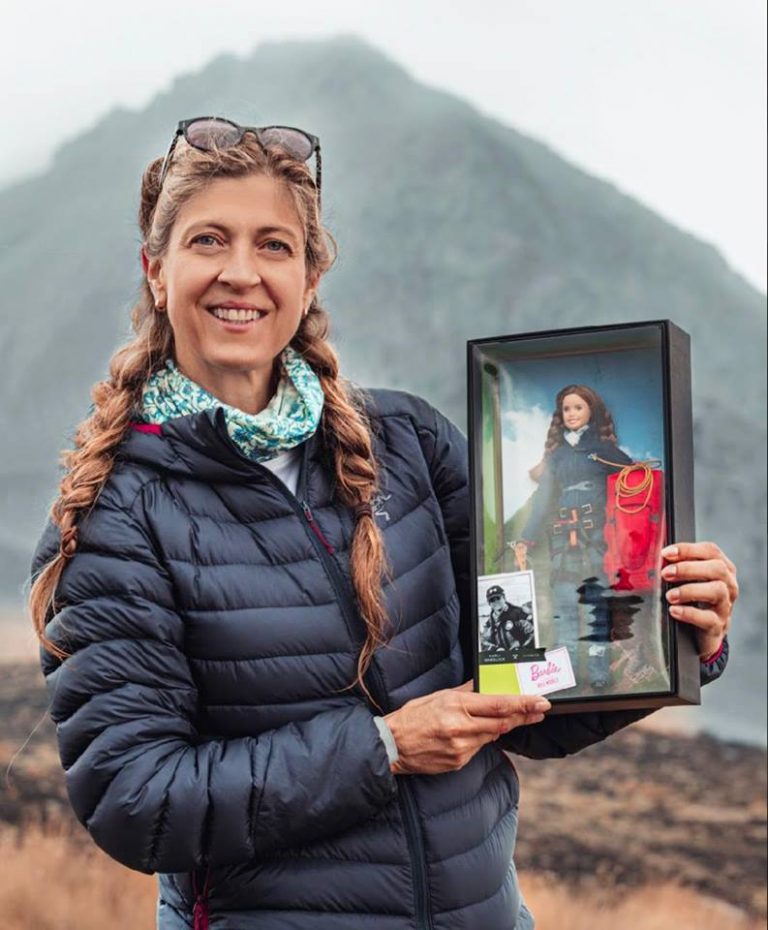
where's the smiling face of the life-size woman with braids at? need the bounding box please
[147,175,317,412]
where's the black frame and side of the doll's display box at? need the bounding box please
[467,320,700,714]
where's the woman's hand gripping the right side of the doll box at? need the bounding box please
[661,542,739,659]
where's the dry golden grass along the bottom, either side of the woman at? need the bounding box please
[0,827,765,930]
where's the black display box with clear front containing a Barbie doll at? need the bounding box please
[467,320,699,713]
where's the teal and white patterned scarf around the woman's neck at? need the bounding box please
[141,346,324,462]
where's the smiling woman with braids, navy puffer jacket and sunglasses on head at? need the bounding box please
[30,121,736,930]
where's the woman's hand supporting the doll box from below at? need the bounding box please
[384,681,552,775]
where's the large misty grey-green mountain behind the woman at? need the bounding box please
[0,37,766,739]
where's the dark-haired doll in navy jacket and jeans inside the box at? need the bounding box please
[522,384,640,691]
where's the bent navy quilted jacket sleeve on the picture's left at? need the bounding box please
[32,497,396,873]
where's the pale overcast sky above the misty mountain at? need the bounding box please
[0,0,766,291]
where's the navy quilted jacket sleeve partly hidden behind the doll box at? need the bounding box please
[423,402,728,759]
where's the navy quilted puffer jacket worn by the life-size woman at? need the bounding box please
[32,391,727,930]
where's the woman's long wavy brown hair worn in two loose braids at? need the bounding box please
[28,135,389,697]
